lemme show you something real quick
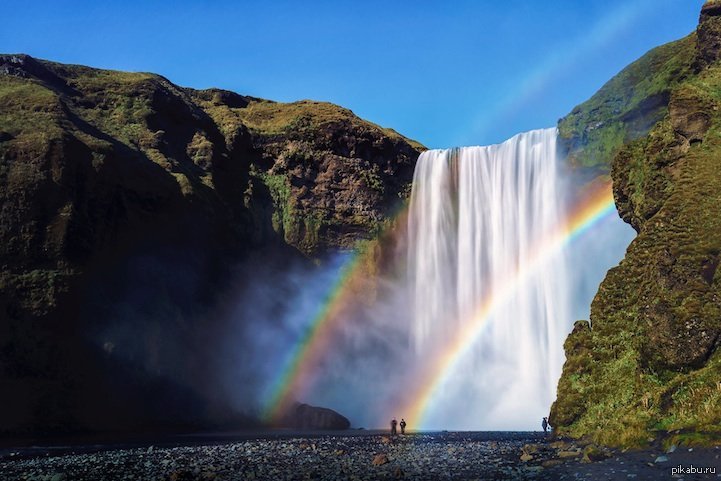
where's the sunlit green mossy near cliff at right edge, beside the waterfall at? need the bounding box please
[551,2,721,446]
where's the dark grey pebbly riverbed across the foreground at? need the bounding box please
[0,431,721,481]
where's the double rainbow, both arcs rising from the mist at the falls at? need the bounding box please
[263,178,616,427]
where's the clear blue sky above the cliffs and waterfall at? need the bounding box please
[0,0,703,148]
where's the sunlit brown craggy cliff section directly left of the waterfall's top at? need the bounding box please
[194,95,424,256]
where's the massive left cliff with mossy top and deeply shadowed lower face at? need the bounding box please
[0,55,423,432]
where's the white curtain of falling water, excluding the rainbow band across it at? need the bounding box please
[408,129,570,429]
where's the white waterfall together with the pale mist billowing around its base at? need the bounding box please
[268,129,635,431]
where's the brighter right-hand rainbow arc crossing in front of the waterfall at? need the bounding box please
[400,178,616,426]
